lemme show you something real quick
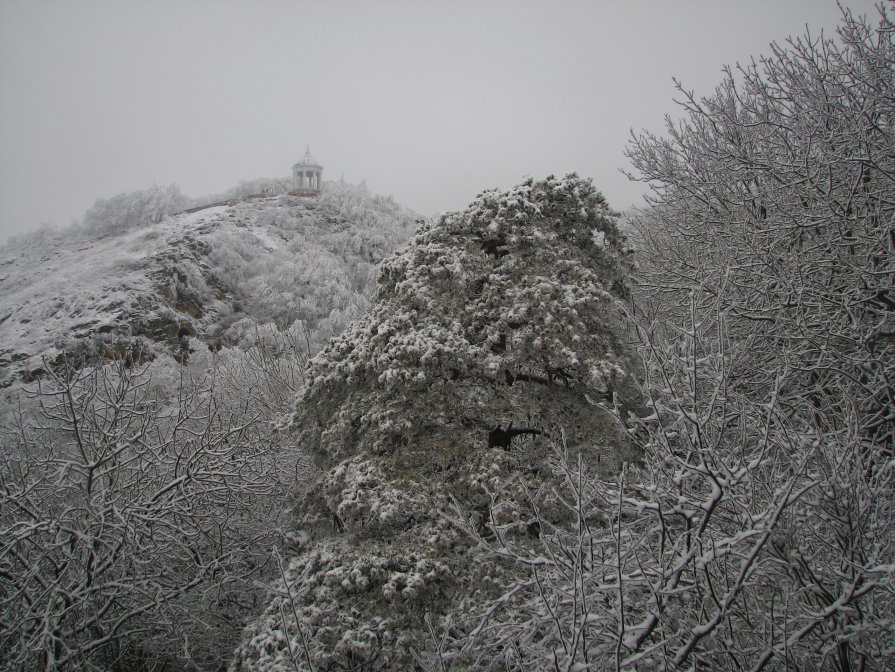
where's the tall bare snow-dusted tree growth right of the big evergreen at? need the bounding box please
[440,10,895,672]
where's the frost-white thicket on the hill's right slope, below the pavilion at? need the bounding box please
[209,183,416,334]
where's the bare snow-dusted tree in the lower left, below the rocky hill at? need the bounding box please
[0,360,281,669]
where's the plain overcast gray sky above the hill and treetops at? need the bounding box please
[0,0,874,239]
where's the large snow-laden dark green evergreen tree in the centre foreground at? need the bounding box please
[234,175,636,670]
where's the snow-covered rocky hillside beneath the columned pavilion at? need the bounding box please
[0,183,416,387]
